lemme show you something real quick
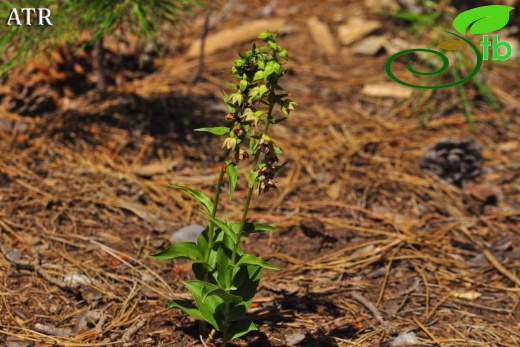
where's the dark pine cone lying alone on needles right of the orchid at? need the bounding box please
[420,139,482,187]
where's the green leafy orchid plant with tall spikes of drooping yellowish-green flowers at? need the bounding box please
[151,32,296,347]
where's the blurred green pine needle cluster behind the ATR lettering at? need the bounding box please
[0,0,202,76]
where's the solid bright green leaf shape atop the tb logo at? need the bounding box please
[453,5,514,35]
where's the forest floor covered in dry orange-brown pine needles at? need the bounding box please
[0,1,520,347]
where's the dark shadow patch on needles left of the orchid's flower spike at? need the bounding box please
[44,93,223,145]
